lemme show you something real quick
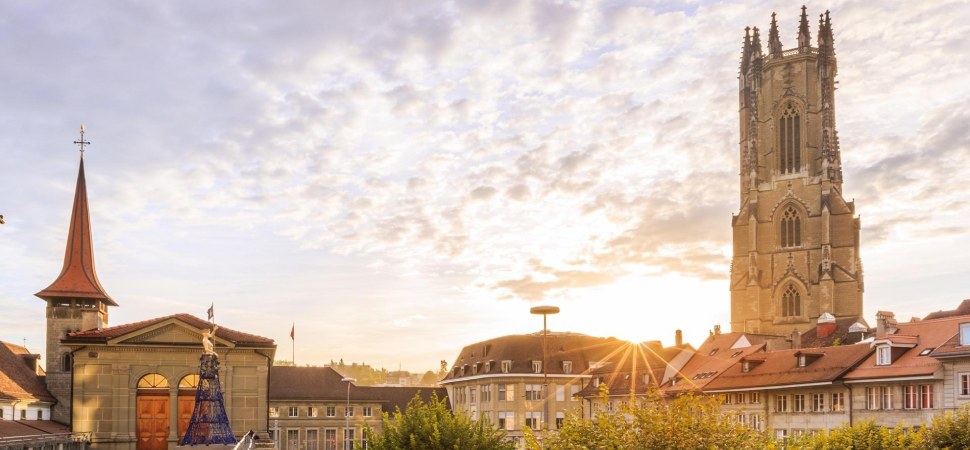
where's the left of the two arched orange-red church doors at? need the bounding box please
[136,373,170,450]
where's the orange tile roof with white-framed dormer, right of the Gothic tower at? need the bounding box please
[845,316,970,381]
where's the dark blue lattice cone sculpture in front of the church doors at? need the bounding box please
[179,328,236,445]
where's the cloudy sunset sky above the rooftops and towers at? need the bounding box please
[0,0,970,372]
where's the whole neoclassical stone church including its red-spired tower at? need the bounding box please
[36,152,276,450]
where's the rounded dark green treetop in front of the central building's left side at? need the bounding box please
[358,393,515,450]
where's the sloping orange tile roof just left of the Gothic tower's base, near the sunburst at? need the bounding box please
[663,333,765,394]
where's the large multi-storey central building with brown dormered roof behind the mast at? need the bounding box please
[441,332,635,440]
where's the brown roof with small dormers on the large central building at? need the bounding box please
[442,332,634,383]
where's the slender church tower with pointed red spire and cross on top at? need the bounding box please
[34,142,118,424]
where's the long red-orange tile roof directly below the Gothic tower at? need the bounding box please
[704,344,872,391]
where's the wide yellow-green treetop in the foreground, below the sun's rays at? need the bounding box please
[526,385,777,450]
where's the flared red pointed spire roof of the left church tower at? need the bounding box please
[34,157,118,306]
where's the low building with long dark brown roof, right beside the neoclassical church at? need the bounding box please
[268,366,447,450]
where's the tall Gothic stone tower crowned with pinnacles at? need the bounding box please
[731,6,863,335]
